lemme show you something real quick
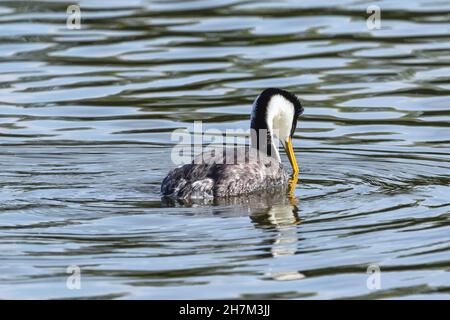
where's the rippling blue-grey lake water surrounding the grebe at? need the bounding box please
[0,0,450,299]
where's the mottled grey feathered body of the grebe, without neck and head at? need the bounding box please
[161,147,289,199]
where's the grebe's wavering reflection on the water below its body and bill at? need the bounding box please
[163,176,304,280]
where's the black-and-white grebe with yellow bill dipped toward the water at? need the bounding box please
[161,88,304,199]
